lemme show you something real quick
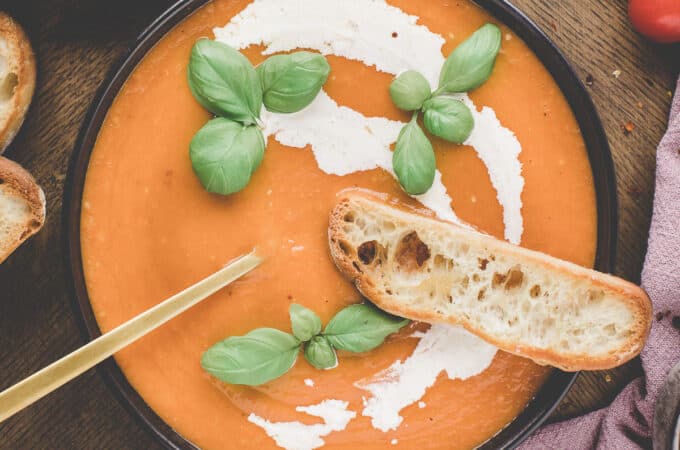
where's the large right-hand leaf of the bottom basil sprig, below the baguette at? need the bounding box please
[323,303,409,352]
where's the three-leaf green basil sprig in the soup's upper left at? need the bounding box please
[187,39,330,195]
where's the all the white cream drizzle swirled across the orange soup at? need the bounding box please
[214,0,524,442]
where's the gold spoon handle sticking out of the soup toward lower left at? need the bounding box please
[0,250,262,422]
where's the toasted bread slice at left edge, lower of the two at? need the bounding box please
[0,156,45,263]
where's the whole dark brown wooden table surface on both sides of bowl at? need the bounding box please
[0,0,680,449]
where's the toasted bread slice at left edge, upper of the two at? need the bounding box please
[0,11,35,154]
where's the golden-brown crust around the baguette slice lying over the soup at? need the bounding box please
[328,190,652,371]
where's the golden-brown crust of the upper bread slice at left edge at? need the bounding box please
[0,11,36,154]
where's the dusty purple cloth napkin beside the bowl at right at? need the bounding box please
[521,80,680,450]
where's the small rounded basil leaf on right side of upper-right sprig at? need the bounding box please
[423,97,475,144]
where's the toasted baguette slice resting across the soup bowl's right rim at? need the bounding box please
[328,190,652,371]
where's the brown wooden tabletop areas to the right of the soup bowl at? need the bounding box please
[513,0,680,420]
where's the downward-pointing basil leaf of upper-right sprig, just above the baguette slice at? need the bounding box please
[392,115,436,195]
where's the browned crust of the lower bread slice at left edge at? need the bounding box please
[0,156,46,263]
